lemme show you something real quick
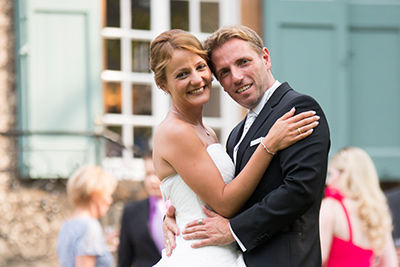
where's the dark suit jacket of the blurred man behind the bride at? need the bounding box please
[118,198,161,267]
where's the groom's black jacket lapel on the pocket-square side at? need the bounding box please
[235,82,291,174]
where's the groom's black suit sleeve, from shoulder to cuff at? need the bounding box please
[230,95,330,251]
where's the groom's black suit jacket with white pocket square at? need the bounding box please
[227,83,330,267]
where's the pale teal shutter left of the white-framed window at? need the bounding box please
[16,0,102,178]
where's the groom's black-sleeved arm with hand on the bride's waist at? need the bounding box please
[182,97,330,251]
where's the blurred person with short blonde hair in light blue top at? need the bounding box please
[57,166,117,267]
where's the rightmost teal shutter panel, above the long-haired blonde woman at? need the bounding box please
[348,1,400,180]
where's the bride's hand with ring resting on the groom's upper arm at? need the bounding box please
[263,108,320,153]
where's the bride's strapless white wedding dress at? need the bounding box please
[155,143,246,267]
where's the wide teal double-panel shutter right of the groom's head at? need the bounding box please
[264,0,400,180]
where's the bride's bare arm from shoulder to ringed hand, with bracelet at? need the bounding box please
[154,110,318,220]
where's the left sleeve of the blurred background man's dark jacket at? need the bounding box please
[118,205,135,267]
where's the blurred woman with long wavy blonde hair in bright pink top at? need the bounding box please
[320,147,398,267]
